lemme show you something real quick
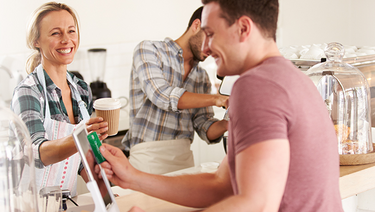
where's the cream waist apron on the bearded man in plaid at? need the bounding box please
[129,139,194,174]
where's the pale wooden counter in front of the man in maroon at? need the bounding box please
[69,162,375,212]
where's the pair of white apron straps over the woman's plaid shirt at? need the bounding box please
[37,64,90,121]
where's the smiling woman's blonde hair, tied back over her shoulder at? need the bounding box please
[26,2,80,74]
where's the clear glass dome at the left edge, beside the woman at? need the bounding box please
[0,100,38,212]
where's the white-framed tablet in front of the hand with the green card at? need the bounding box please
[73,122,120,212]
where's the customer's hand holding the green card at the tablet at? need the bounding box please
[95,143,137,189]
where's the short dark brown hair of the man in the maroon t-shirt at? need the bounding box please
[202,0,279,41]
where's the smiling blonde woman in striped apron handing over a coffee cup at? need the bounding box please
[11,2,108,196]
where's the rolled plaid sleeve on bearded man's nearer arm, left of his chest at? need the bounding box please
[134,41,186,111]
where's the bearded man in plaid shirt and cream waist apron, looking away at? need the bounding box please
[122,7,228,174]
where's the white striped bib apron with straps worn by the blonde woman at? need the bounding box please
[35,64,90,196]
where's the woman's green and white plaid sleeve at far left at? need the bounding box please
[11,77,47,168]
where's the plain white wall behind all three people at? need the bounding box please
[0,0,375,97]
